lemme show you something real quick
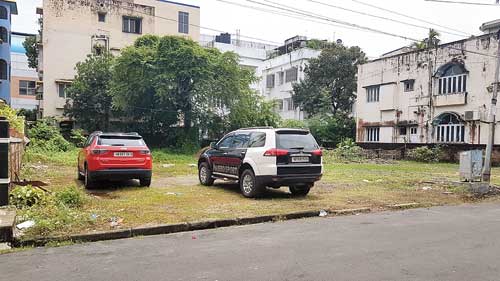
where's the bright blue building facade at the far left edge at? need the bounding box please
[0,0,17,104]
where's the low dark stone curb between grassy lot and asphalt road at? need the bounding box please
[12,208,371,247]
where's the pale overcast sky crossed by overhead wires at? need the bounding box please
[12,0,500,57]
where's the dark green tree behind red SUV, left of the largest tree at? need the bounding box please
[64,54,113,132]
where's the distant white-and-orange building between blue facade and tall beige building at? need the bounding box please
[10,32,40,110]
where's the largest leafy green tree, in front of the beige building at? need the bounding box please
[112,35,276,144]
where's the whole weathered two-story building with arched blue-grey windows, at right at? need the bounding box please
[356,21,500,147]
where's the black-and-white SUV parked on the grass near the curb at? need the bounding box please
[198,127,323,197]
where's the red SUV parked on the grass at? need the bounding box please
[78,132,153,188]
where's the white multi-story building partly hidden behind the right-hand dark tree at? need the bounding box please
[261,36,321,120]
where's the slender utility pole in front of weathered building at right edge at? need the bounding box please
[483,30,500,183]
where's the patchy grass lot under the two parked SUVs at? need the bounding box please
[13,147,500,241]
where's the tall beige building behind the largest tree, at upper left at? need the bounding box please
[37,0,200,116]
